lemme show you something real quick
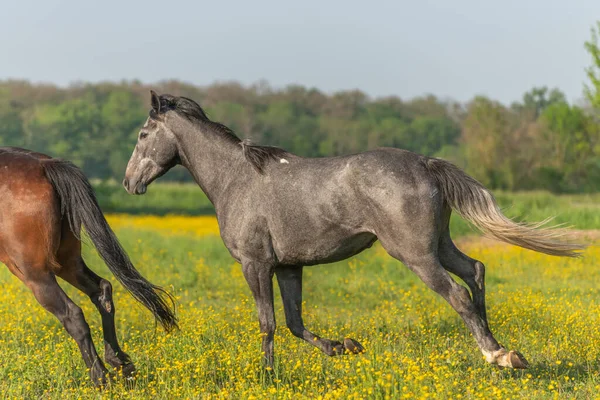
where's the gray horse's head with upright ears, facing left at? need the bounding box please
[123,91,179,194]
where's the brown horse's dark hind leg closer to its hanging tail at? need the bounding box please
[59,256,135,377]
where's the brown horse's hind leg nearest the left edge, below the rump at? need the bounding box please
[24,272,108,386]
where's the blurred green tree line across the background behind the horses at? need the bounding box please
[0,23,600,192]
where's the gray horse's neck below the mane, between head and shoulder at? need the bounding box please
[175,124,248,207]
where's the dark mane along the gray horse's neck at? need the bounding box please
[150,94,289,174]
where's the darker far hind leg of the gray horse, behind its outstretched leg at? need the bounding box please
[438,231,488,326]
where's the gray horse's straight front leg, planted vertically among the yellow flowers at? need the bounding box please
[242,261,275,368]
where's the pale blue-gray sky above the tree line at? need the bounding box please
[0,0,600,103]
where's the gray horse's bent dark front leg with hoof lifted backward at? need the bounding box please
[275,266,364,356]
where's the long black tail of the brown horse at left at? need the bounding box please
[42,159,177,331]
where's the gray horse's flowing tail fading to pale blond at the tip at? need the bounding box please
[425,158,586,257]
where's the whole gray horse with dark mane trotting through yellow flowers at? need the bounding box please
[123,92,584,368]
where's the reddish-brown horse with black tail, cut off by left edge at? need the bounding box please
[0,147,177,385]
